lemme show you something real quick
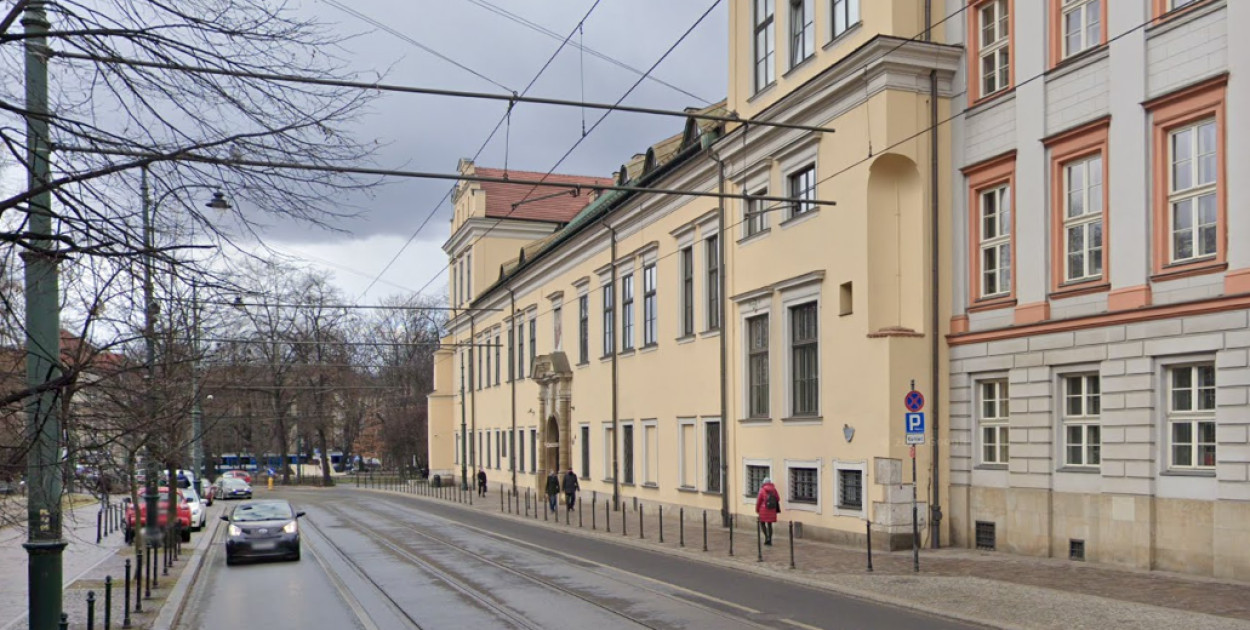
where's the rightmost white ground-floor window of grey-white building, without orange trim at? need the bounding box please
[1168,364,1215,470]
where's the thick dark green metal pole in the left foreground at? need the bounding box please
[21,6,65,630]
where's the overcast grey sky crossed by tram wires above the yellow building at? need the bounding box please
[266,0,729,303]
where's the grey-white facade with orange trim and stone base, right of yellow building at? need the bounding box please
[946,1,1250,576]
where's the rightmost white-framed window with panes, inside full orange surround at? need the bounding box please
[1168,119,1219,263]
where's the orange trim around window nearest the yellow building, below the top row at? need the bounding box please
[963,151,1019,310]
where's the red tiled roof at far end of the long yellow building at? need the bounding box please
[475,166,613,223]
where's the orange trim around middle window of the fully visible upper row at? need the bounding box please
[1043,116,1111,298]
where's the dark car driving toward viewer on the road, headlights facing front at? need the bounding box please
[221,500,304,565]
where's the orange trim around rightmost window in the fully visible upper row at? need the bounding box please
[1144,74,1229,278]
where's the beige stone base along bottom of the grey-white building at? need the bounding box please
[950,486,1250,580]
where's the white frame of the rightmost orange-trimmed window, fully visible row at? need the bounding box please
[1165,116,1220,263]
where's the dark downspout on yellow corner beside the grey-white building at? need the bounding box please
[925,0,941,549]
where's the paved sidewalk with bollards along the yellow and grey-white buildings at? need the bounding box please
[360,484,1250,630]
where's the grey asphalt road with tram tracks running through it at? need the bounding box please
[180,489,971,630]
